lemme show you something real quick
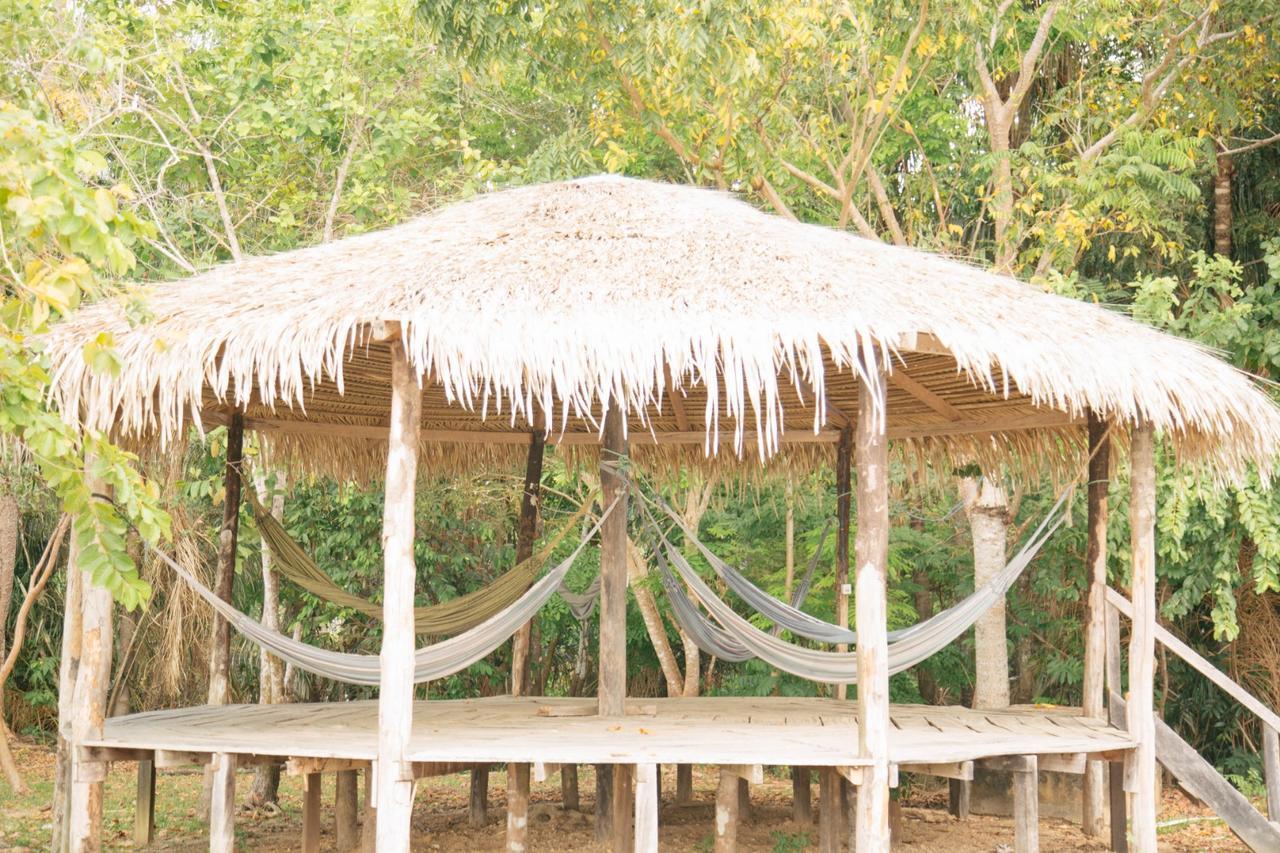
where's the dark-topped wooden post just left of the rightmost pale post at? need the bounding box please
[1080,411,1111,836]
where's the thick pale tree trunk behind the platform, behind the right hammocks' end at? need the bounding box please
[960,476,1009,708]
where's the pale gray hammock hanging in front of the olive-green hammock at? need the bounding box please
[147,498,618,686]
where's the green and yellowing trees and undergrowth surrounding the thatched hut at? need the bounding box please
[0,0,1280,809]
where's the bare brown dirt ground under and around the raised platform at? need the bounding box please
[0,744,1245,853]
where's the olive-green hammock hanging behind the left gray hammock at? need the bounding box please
[243,489,590,637]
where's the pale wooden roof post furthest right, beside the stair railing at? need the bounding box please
[1128,423,1157,853]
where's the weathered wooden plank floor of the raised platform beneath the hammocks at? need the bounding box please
[87,697,1134,767]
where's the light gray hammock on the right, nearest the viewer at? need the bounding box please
[645,489,1070,684]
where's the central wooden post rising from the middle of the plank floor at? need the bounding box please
[599,400,627,717]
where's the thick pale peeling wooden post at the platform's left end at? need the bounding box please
[68,461,114,853]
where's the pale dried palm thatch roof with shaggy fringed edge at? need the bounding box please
[40,177,1280,476]
